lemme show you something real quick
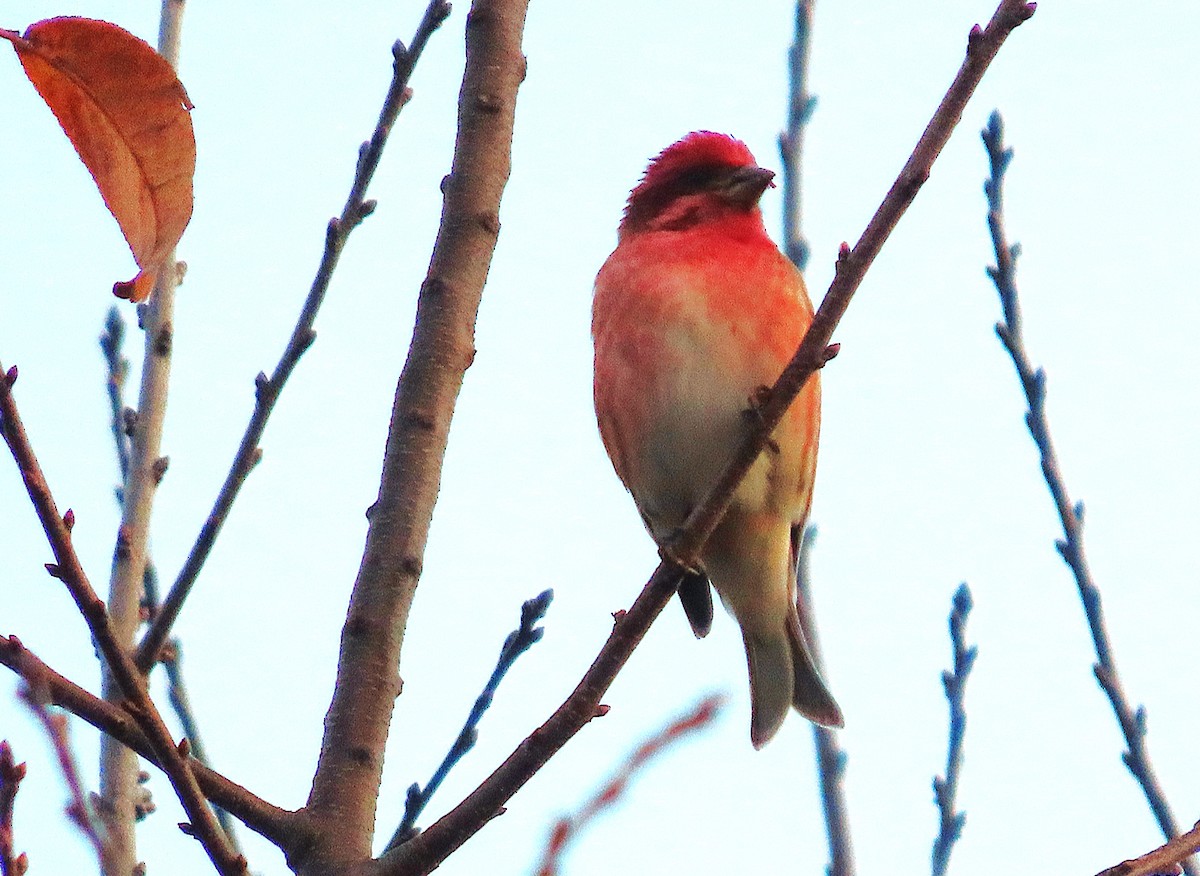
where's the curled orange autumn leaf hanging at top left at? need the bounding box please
[0,18,196,301]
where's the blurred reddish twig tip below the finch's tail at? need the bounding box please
[538,694,725,876]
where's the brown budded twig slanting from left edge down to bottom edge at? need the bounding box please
[0,367,246,876]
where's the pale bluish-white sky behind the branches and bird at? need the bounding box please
[0,0,1200,876]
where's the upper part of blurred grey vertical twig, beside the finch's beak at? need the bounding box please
[779,0,817,271]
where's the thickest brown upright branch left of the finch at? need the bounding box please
[298,0,528,868]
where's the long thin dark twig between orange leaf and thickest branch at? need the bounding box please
[137,0,450,671]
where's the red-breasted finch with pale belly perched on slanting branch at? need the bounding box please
[592,131,842,748]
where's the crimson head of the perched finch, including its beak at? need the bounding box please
[619,131,775,235]
